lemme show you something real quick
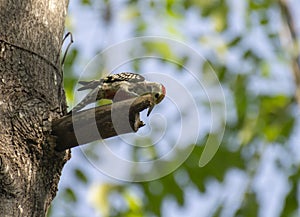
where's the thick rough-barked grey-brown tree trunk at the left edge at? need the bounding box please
[0,0,70,217]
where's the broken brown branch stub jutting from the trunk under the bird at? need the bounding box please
[51,95,153,151]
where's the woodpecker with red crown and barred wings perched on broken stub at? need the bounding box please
[72,72,166,116]
